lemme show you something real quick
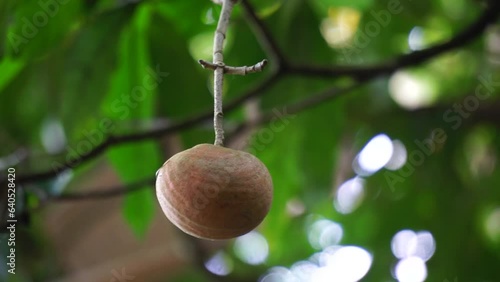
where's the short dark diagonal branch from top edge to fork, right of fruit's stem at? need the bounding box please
[241,0,288,69]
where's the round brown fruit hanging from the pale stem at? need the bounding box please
[156,144,273,240]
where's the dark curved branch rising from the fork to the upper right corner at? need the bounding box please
[289,0,500,79]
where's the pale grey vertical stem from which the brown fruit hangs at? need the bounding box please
[213,0,234,146]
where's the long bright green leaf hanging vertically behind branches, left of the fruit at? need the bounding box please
[102,6,163,237]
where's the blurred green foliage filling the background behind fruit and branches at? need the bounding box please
[0,0,500,282]
